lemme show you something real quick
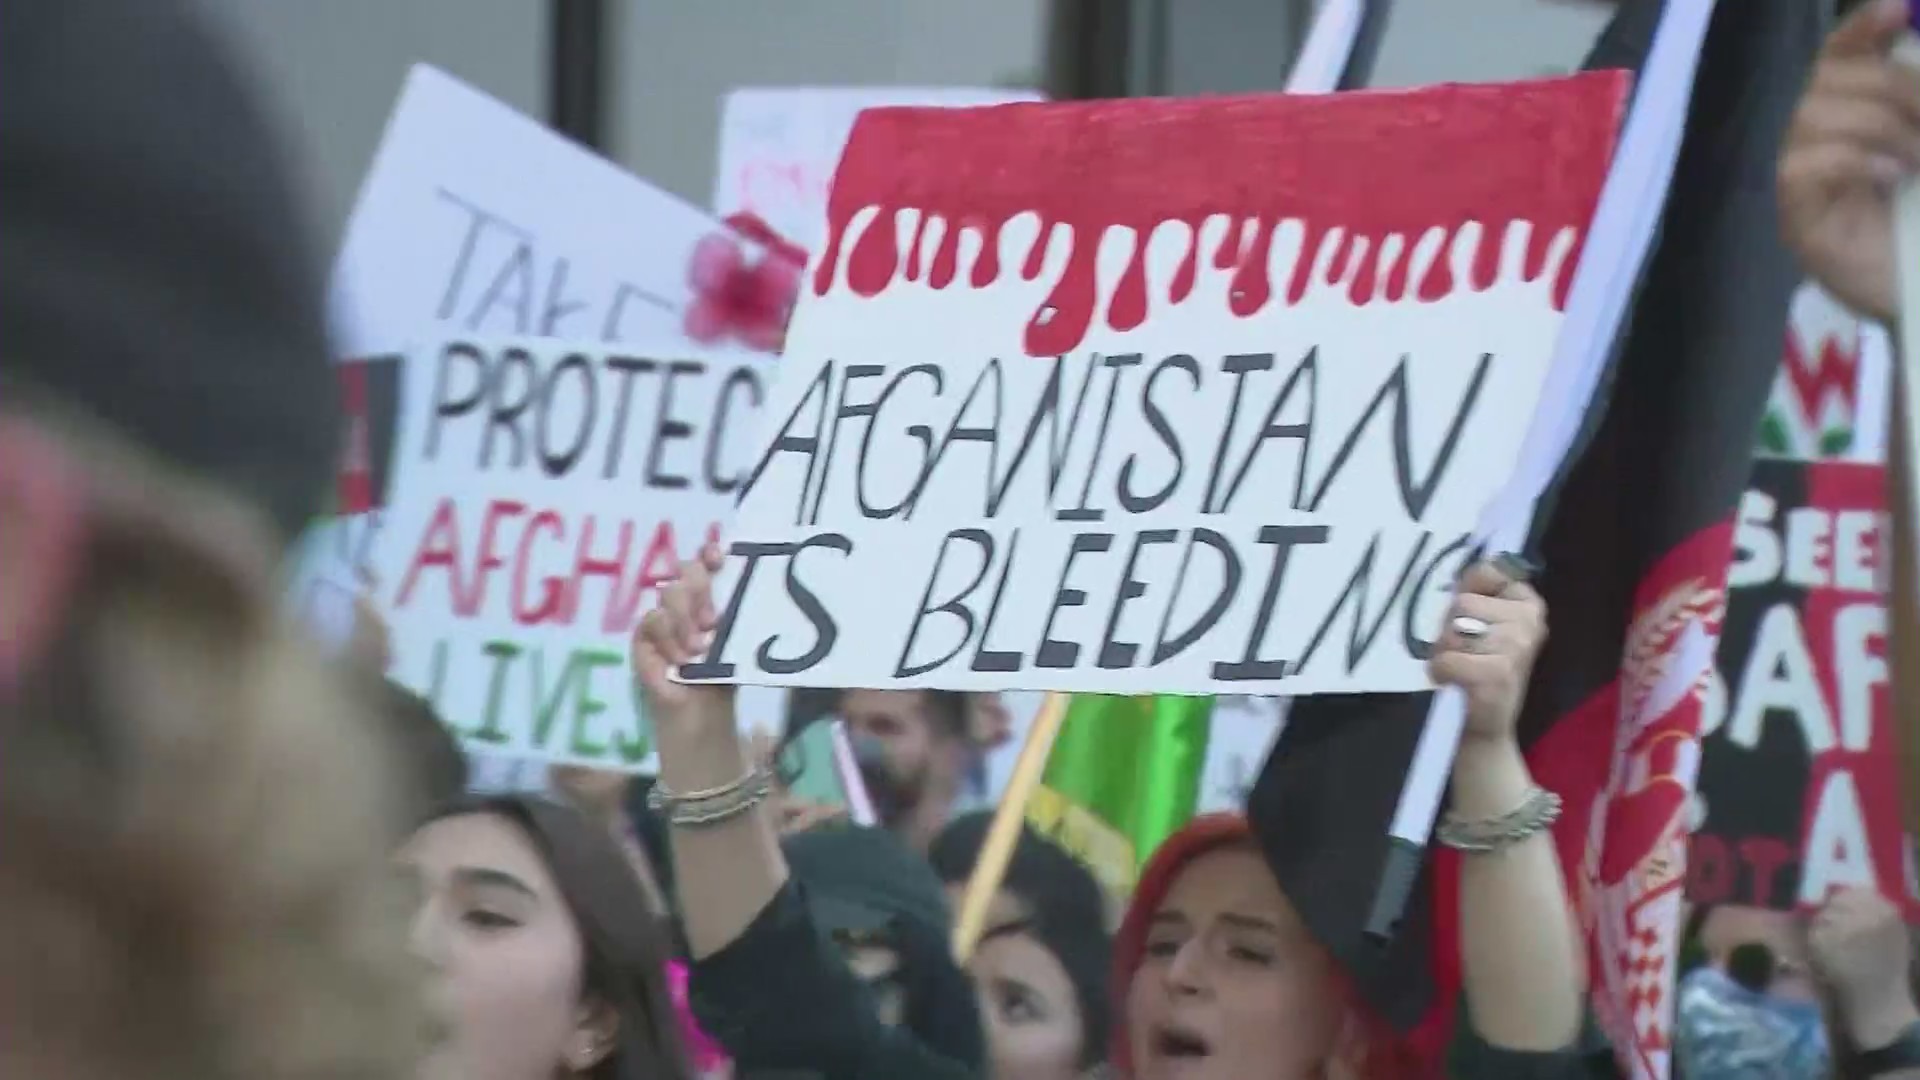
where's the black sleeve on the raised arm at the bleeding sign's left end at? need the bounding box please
[689,882,983,1080]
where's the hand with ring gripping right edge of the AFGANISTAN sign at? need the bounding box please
[1427,559,1548,744]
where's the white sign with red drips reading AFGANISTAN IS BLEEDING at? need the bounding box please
[685,75,1624,694]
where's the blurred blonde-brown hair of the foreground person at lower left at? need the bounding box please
[0,402,424,1080]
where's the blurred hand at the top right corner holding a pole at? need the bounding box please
[1778,0,1920,323]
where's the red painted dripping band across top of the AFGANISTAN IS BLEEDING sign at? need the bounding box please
[814,71,1628,356]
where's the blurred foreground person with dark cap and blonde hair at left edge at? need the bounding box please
[0,0,420,1080]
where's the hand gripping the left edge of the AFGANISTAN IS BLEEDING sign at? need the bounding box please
[634,544,737,737]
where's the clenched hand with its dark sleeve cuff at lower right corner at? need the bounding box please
[1807,888,1920,1080]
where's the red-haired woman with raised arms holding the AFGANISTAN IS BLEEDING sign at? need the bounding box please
[634,546,1588,1080]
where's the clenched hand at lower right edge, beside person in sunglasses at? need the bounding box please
[1807,888,1920,1047]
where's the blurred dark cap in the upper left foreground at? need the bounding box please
[0,0,340,542]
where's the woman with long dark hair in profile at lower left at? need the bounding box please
[401,796,695,1080]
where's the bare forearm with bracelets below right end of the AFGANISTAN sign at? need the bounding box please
[1453,740,1586,1051]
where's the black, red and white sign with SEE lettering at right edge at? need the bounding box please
[1688,284,1920,913]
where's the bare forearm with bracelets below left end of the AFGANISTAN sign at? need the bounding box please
[660,721,787,959]
